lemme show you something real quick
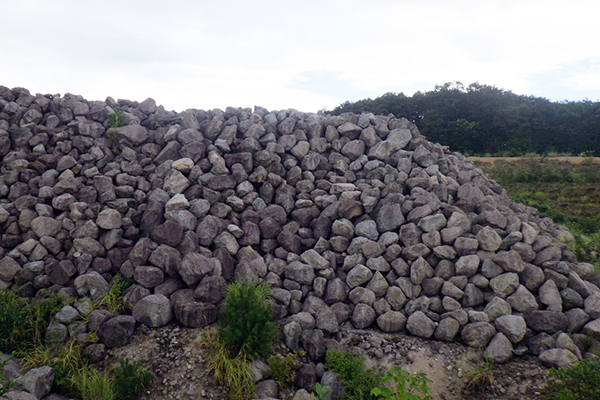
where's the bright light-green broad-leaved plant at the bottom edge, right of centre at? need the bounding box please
[371,366,431,400]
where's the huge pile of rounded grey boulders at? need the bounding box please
[0,87,600,364]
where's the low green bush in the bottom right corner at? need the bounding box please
[544,359,600,400]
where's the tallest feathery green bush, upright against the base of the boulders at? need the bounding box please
[218,281,276,358]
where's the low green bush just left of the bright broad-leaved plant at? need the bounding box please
[325,349,383,400]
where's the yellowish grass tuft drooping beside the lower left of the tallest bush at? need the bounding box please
[201,329,254,400]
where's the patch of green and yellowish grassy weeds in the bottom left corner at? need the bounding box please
[0,290,152,400]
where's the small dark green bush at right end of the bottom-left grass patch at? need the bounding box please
[112,359,153,400]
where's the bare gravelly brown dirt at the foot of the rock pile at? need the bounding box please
[105,325,546,400]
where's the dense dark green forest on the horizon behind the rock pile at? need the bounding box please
[328,82,600,156]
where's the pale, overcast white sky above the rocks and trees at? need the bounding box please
[0,0,600,112]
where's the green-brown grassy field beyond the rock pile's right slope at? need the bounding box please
[472,157,600,268]
